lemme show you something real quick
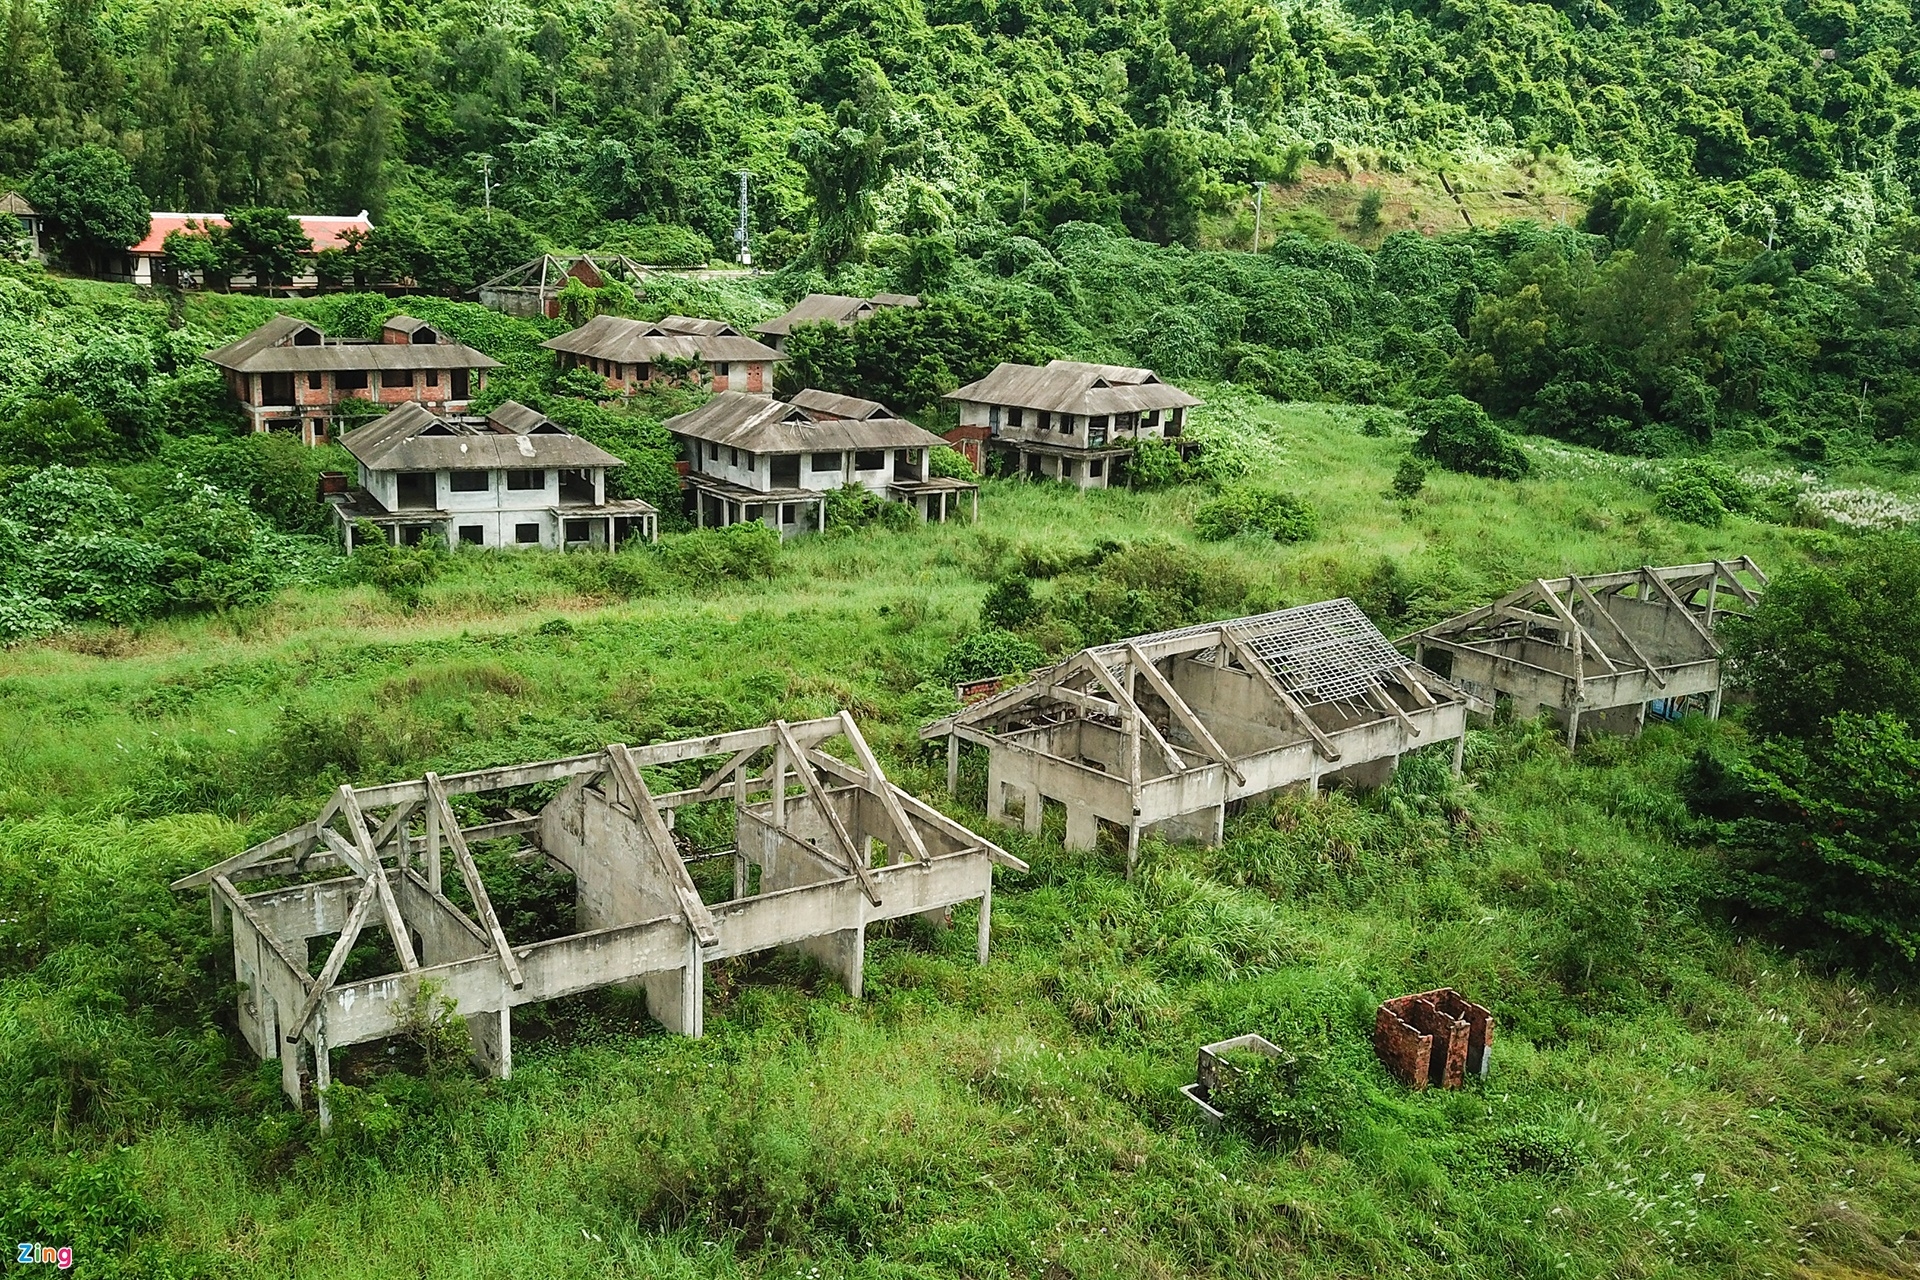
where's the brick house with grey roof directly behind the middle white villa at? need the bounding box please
[540,315,785,395]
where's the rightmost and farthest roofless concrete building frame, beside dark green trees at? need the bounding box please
[1400,557,1766,747]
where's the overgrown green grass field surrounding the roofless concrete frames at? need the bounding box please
[0,390,1920,1280]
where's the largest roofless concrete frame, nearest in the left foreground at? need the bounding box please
[173,712,1025,1125]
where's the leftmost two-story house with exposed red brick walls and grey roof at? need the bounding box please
[202,315,499,445]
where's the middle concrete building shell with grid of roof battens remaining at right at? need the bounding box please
[920,599,1467,873]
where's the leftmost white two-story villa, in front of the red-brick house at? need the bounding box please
[334,399,659,551]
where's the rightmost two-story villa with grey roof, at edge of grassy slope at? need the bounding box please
[947,361,1200,489]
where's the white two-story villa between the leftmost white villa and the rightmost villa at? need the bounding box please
[666,391,979,537]
